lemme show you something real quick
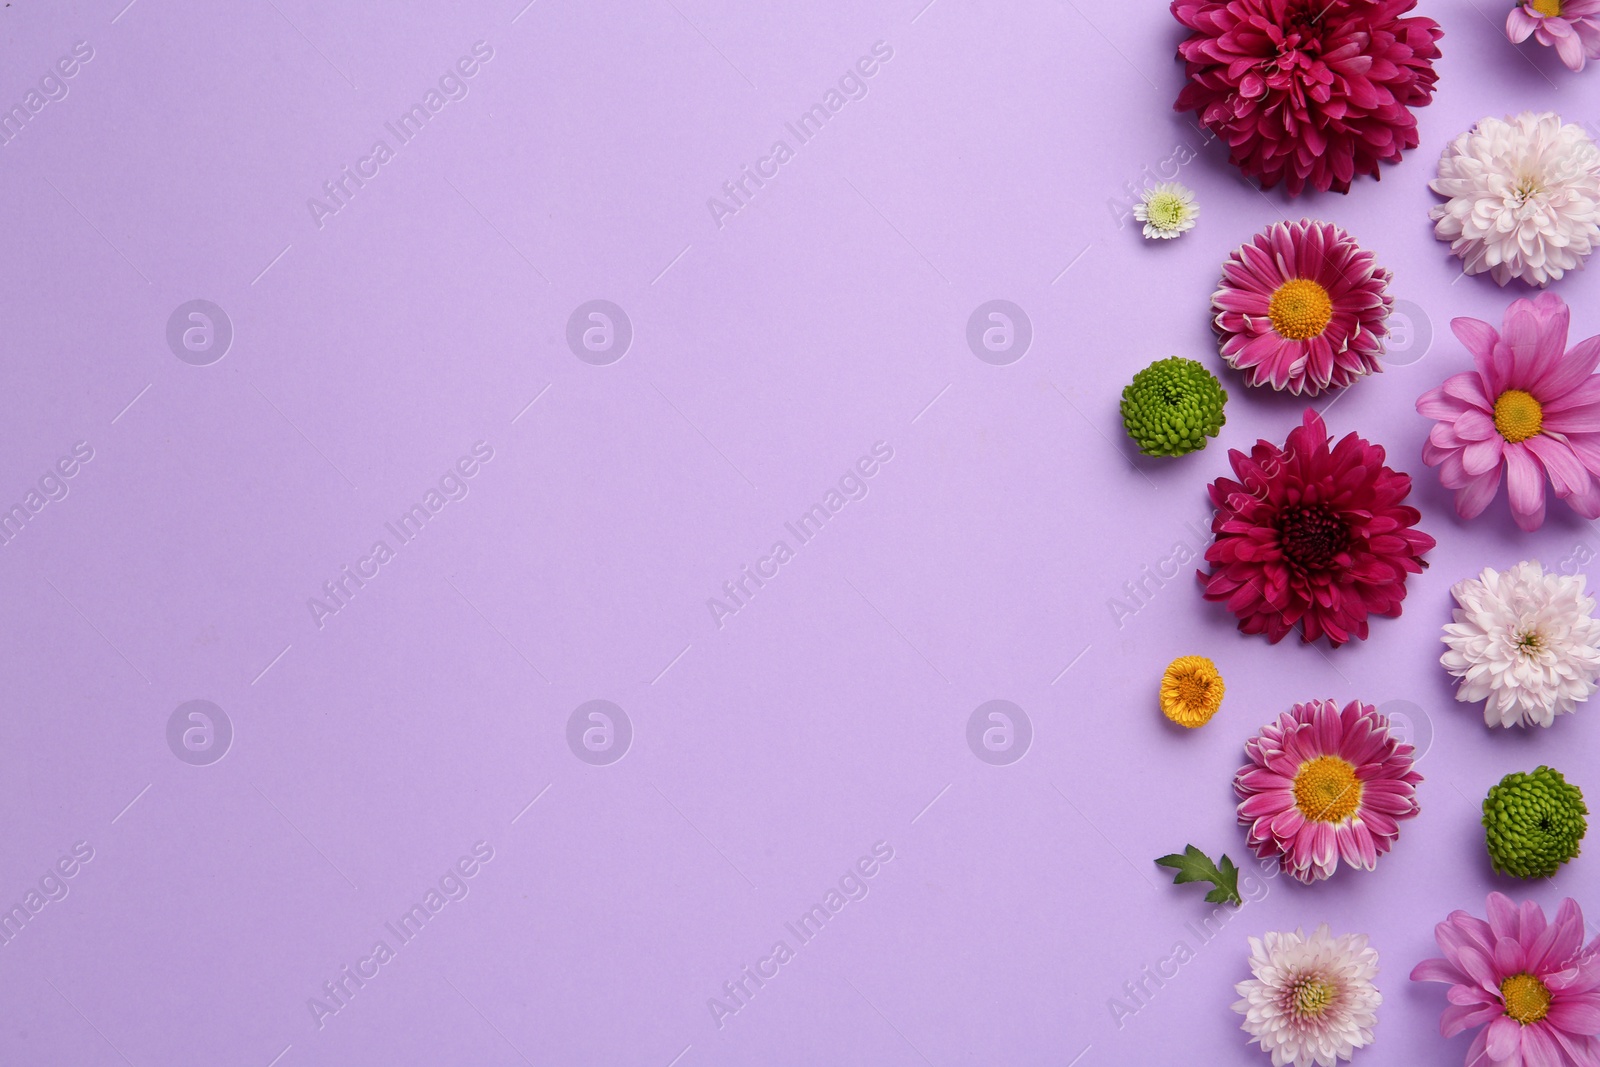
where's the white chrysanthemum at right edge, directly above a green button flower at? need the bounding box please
[1438,560,1600,726]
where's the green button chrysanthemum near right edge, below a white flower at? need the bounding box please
[1483,766,1589,878]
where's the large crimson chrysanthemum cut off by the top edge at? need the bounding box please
[1173,0,1443,195]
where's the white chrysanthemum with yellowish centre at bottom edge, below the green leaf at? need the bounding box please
[1234,923,1384,1067]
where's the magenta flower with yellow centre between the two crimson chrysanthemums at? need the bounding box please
[1211,219,1394,397]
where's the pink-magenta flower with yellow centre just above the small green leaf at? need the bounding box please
[1234,701,1422,885]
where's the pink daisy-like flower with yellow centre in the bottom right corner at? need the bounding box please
[1411,893,1600,1067]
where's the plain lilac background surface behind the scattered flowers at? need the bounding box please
[0,0,1600,1067]
